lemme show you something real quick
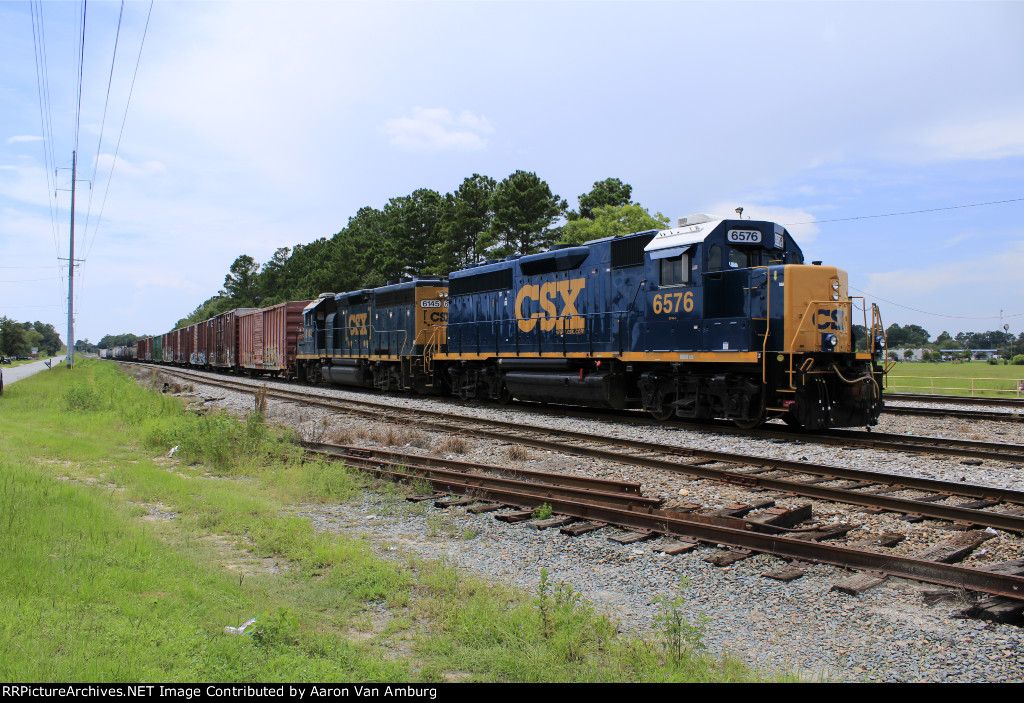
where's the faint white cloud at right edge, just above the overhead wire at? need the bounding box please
[918,115,1024,161]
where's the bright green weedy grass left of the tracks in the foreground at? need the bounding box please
[0,360,770,682]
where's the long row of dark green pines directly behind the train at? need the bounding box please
[172,171,669,331]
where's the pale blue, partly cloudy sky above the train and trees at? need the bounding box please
[0,1,1024,342]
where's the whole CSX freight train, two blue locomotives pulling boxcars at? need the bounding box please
[110,215,885,430]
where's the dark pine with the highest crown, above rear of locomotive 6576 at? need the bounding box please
[481,171,567,257]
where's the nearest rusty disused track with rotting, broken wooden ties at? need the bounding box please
[306,443,1024,610]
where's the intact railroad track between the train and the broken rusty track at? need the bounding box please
[146,368,1024,533]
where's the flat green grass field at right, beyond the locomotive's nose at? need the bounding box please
[886,361,1024,398]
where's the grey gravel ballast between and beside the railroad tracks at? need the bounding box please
[128,369,1024,682]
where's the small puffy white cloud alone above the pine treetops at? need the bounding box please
[381,107,494,151]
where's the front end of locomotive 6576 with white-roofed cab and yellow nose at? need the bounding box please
[641,215,882,429]
